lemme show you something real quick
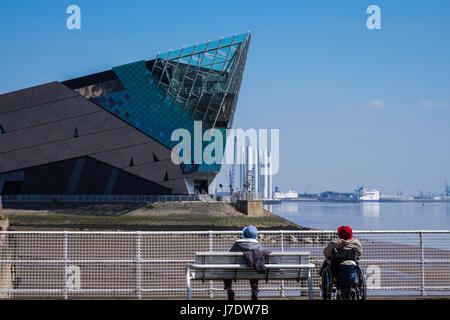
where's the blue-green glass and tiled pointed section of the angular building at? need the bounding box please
[75,33,250,173]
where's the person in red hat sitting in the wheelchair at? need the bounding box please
[320,226,362,299]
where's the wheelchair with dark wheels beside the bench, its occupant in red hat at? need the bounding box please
[320,249,367,300]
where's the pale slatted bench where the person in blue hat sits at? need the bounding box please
[186,251,314,300]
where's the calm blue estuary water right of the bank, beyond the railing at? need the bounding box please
[264,202,450,230]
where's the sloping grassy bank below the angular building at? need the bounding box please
[3,202,305,231]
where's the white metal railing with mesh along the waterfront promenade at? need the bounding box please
[0,231,450,299]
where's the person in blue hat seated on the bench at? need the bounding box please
[224,226,262,300]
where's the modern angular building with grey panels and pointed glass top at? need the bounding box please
[0,33,250,195]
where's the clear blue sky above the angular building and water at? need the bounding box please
[0,0,450,194]
